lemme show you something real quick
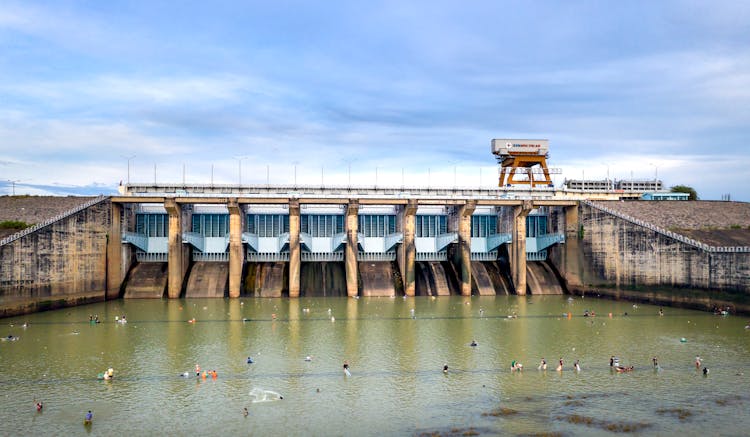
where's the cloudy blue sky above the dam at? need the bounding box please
[0,0,750,201]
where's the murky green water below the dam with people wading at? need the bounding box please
[0,296,750,436]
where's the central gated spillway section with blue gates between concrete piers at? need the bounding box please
[108,184,640,298]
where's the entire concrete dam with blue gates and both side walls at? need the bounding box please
[0,185,750,316]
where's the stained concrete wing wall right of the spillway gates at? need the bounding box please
[549,202,750,312]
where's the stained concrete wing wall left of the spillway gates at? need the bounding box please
[0,198,113,316]
